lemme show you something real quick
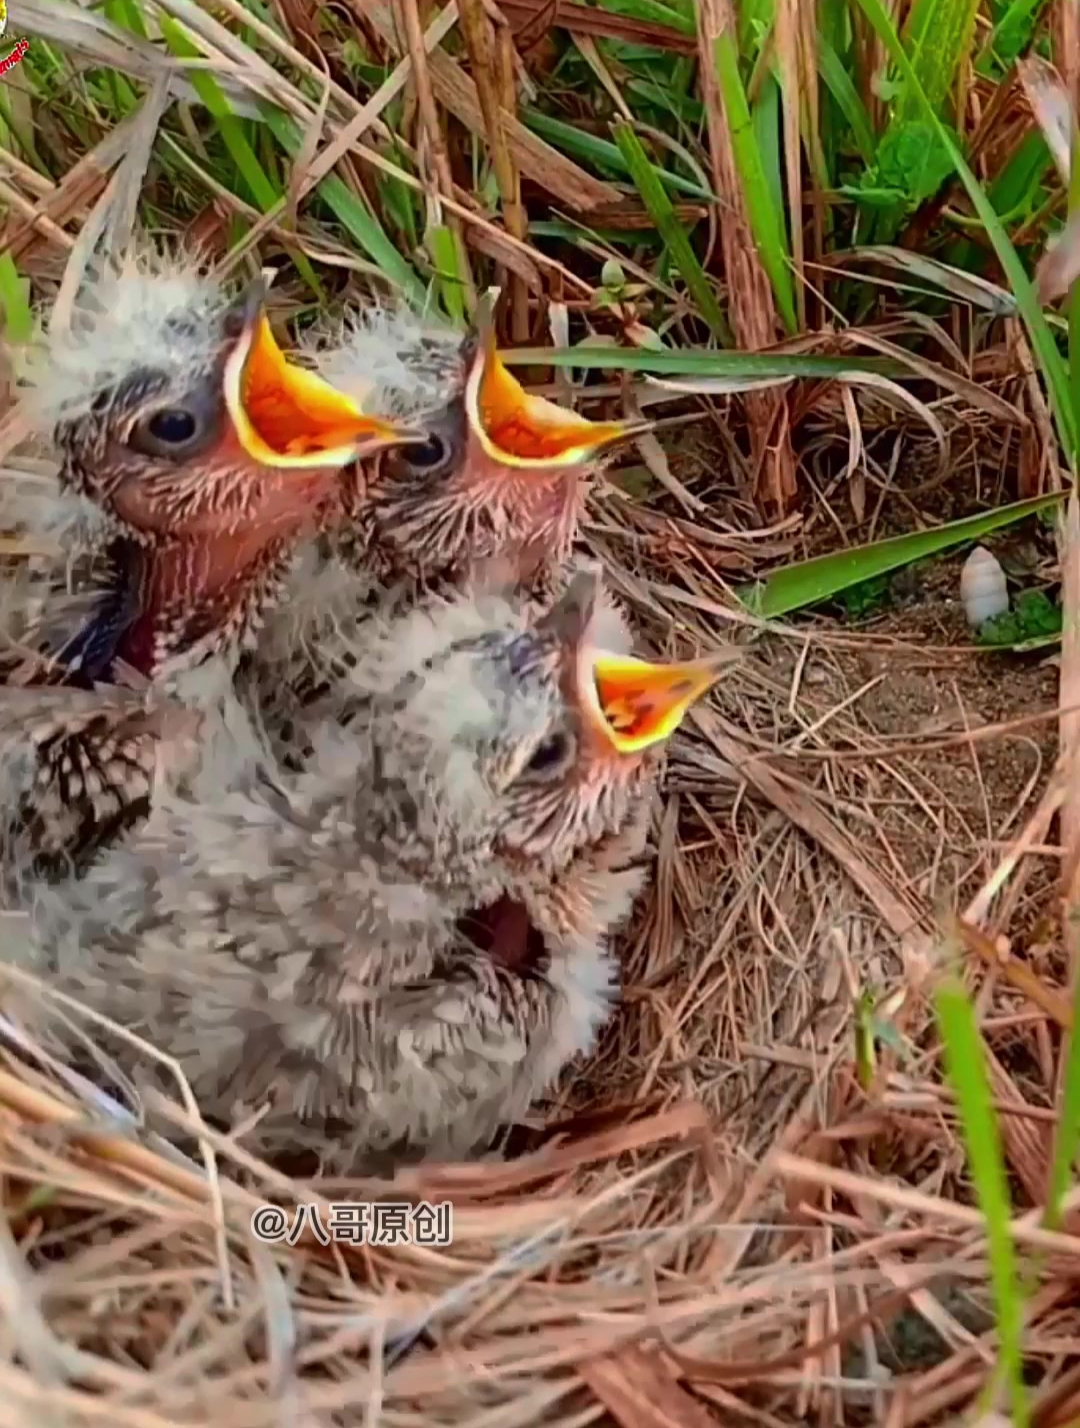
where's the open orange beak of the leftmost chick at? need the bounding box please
[224,284,411,470]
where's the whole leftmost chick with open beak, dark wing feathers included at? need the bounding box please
[0,251,417,879]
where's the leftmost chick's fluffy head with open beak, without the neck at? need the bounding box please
[29,261,416,544]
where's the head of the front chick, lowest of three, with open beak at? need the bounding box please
[345,570,733,891]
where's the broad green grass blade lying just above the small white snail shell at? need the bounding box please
[736,491,1064,620]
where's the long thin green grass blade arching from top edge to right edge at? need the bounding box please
[856,0,1080,473]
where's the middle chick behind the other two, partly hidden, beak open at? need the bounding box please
[250,300,649,765]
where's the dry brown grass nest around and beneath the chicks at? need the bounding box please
[0,414,1077,1428]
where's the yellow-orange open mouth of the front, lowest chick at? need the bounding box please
[587,650,740,754]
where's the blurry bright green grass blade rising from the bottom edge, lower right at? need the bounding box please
[936,980,1030,1428]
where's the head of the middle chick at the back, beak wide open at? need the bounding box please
[315,295,647,575]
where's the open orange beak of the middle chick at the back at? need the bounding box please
[466,288,651,470]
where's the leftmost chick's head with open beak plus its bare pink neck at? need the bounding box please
[26,251,419,674]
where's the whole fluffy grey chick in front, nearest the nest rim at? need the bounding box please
[4,571,727,1170]
